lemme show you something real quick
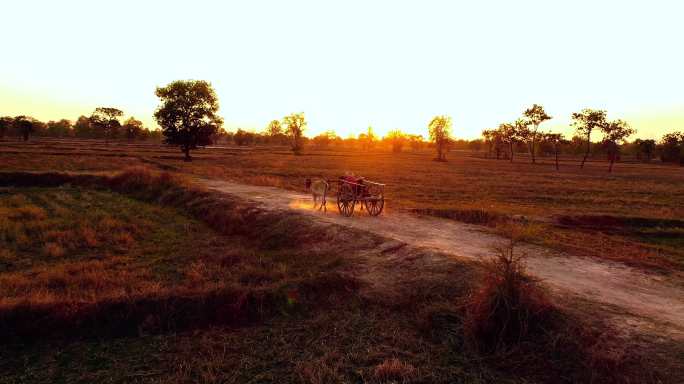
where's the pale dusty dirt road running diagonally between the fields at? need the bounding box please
[199,180,684,340]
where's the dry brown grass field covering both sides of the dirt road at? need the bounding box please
[0,140,684,383]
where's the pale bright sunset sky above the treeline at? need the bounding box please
[0,0,684,138]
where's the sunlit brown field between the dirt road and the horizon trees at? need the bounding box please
[0,140,684,272]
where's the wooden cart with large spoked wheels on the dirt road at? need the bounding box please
[337,177,385,217]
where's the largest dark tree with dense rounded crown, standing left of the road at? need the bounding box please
[154,80,223,161]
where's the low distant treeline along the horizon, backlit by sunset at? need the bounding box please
[0,107,684,165]
